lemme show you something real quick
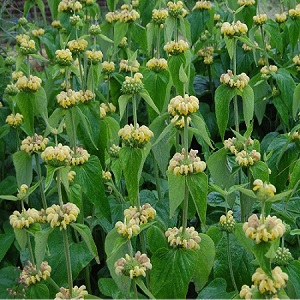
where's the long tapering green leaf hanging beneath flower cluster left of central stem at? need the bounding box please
[119,146,150,205]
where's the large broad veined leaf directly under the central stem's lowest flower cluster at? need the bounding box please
[150,248,197,299]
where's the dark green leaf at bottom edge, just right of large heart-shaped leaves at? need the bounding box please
[197,278,236,299]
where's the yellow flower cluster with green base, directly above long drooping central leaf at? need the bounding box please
[118,124,153,148]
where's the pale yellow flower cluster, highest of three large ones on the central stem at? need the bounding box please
[168,94,199,117]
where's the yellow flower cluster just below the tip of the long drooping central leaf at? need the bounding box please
[124,203,156,225]
